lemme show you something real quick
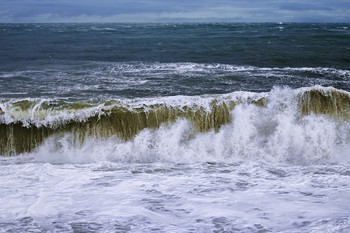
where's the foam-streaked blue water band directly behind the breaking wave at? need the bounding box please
[0,62,350,100]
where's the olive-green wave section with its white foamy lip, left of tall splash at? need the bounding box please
[0,95,235,154]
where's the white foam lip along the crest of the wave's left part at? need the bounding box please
[0,89,267,126]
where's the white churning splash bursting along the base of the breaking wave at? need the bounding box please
[26,87,350,164]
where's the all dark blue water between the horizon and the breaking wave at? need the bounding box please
[0,23,350,99]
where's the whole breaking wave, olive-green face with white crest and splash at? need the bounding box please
[0,86,350,163]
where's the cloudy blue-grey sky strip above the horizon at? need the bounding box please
[0,0,350,23]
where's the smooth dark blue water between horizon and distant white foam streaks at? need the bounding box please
[0,24,350,70]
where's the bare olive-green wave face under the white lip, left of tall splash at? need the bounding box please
[0,101,234,154]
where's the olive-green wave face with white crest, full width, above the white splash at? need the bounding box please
[0,87,350,155]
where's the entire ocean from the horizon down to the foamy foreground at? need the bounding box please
[0,23,350,233]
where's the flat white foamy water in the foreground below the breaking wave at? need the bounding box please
[0,158,350,232]
